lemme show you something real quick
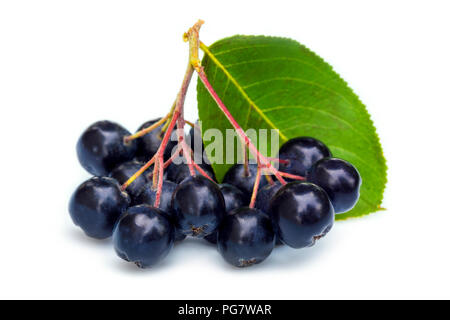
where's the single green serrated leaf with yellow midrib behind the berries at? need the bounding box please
[197,36,387,219]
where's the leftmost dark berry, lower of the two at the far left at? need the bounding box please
[69,177,130,239]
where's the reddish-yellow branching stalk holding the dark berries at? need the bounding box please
[122,20,305,207]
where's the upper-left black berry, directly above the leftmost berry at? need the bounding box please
[77,121,136,176]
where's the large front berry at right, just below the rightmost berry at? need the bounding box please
[269,182,334,248]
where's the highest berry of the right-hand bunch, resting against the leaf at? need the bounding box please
[279,137,331,176]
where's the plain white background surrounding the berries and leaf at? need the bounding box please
[0,0,450,299]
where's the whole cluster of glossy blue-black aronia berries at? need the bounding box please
[69,116,361,268]
